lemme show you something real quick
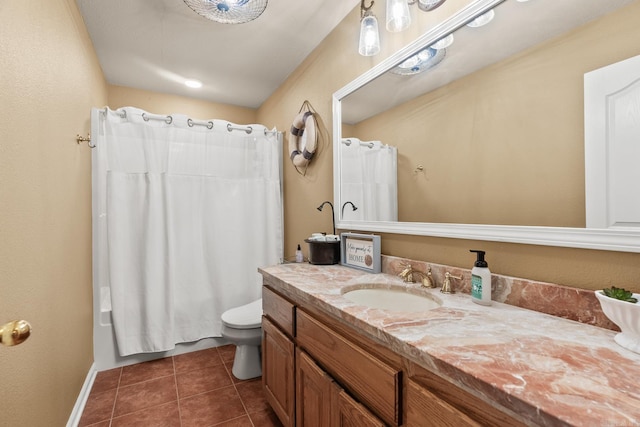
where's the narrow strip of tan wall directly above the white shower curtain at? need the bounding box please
[108,85,257,124]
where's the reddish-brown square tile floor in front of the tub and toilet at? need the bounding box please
[79,345,281,427]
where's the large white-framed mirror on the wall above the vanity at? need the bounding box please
[333,0,640,252]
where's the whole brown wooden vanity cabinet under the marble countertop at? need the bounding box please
[262,280,525,427]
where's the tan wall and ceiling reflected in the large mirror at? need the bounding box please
[342,0,636,227]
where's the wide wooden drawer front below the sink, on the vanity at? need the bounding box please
[296,310,401,425]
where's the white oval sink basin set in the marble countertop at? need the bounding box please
[342,288,442,312]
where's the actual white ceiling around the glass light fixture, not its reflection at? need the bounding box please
[76,0,359,108]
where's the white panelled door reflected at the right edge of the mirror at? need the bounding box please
[584,56,640,228]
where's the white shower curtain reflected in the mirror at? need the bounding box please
[340,138,398,221]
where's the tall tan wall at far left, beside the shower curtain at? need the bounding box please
[0,0,107,427]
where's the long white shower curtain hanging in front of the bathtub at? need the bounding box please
[92,107,283,356]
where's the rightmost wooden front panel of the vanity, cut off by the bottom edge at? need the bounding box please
[406,380,480,427]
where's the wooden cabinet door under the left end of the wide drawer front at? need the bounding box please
[296,349,333,427]
